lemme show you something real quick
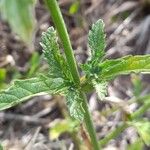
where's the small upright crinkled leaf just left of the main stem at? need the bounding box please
[41,27,72,80]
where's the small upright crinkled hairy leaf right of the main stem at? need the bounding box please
[80,19,106,78]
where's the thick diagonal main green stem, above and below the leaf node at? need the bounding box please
[44,0,100,150]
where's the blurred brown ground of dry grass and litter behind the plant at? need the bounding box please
[0,0,150,150]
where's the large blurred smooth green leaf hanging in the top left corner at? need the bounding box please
[0,0,35,44]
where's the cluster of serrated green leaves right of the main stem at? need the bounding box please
[81,19,150,100]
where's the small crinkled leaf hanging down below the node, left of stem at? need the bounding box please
[66,88,84,121]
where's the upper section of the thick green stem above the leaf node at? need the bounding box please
[44,0,80,84]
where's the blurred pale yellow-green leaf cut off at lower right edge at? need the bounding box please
[130,120,150,146]
